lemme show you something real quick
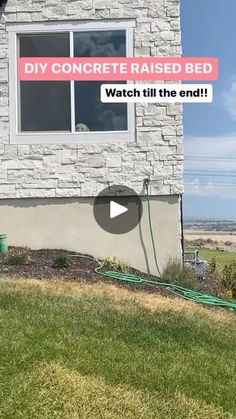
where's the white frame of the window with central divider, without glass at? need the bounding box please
[7,20,135,144]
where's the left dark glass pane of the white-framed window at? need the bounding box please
[19,34,71,131]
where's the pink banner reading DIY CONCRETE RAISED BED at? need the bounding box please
[19,57,219,81]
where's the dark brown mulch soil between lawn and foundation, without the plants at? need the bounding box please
[0,247,172,298]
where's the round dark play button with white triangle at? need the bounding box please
[93,185,143,234]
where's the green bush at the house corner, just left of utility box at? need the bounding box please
[161,260,199,289]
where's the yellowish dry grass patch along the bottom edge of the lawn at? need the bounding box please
[1,364,233,419]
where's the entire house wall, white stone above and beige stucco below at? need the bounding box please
[0,0,183,273]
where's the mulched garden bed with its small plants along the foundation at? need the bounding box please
[0,247,230,298]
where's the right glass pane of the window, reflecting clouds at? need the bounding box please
[74,31,128,131]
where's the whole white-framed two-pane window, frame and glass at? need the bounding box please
[8,21,135,144]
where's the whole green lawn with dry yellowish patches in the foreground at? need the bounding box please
[0,279,236,419]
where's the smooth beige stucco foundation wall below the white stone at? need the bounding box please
[0,195,181,274]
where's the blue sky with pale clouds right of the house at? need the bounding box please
[181,0,236,219]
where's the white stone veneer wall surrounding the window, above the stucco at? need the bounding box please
[0,0,183,198]
